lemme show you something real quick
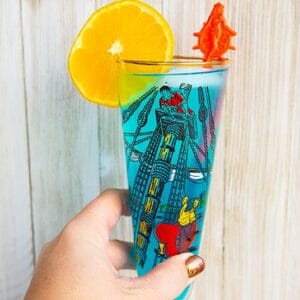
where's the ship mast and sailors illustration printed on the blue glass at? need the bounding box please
[122,83,215,267]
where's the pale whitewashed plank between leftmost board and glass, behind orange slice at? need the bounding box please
[22,0,99,252]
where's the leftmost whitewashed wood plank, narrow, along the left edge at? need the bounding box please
[0,0,33,300]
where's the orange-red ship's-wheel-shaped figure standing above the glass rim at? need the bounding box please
[193,2,236,62]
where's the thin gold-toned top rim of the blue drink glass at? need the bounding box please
[118,55,230,68]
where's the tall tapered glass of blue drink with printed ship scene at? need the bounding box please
[121,58,228,299]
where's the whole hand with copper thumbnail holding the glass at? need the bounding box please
[25,189,204,300]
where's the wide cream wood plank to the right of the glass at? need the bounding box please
[223,1,300,300]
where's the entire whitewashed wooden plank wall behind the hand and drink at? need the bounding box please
[0,0,300,300]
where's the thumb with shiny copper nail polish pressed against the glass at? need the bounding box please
[138,253,205,299]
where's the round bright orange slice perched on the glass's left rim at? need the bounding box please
[69,0,174,107]
